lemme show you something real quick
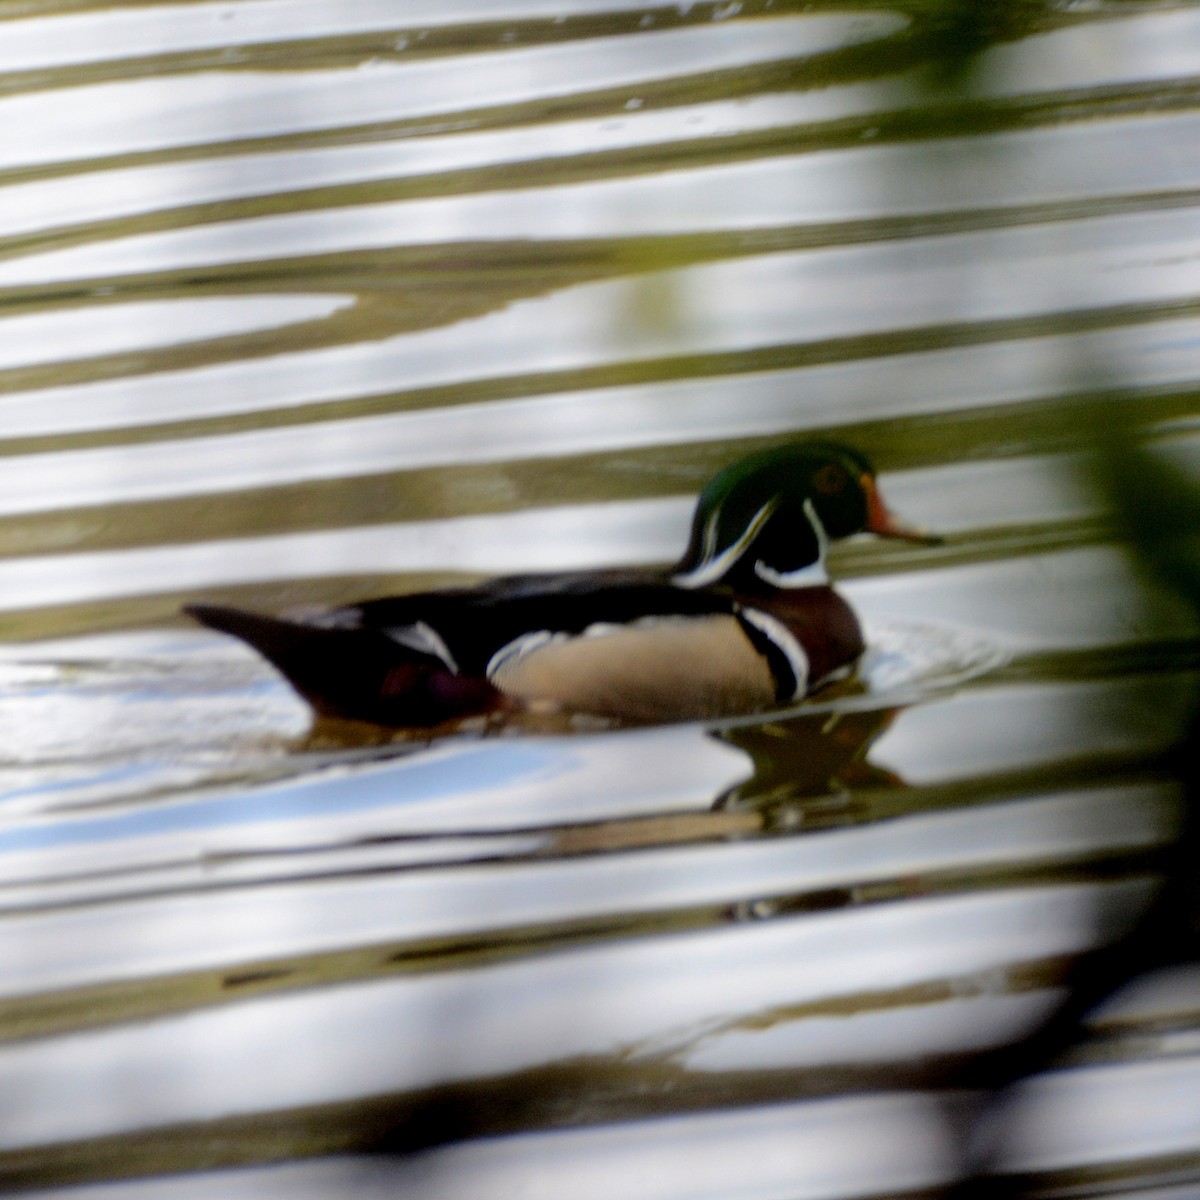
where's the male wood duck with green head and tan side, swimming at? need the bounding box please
[185,442,936,728]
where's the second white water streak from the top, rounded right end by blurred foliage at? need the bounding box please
[0,13,906,169]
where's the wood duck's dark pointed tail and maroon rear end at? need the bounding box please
[184,605,499,727]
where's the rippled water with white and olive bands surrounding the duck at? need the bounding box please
[0,0,1200,1200]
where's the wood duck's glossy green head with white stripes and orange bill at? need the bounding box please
[673,442,937,590]
